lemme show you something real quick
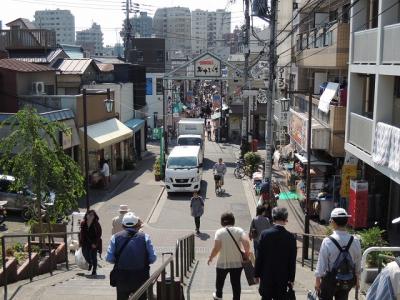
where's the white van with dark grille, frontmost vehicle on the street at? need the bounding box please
[165,146,203,193]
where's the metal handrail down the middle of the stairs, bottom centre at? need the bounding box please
[129,234,195,300]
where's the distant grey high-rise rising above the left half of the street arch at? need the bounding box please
[153,7,192,55]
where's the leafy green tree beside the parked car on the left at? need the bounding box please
[0,107,85,229]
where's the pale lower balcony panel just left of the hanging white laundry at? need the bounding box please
[349,113,374,154]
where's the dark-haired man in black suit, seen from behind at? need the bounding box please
[255,207,297,300]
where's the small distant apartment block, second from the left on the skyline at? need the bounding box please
[76,23,103,55]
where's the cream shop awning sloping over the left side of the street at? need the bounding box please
[80,118,133,150]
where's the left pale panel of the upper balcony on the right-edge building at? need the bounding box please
[353,28,378,64]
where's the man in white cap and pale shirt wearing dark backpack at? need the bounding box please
[315,208,361,300]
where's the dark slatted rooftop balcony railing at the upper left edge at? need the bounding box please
[0,29,57,50]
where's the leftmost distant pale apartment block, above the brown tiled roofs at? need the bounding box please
[34,9,75,45]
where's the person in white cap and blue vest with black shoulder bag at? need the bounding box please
[106,212,157,300]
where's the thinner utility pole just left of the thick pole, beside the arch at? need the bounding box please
[242,0,250,142]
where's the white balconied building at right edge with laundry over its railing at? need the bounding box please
[345,0,400,244]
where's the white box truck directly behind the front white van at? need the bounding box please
[177,118,205,161]
